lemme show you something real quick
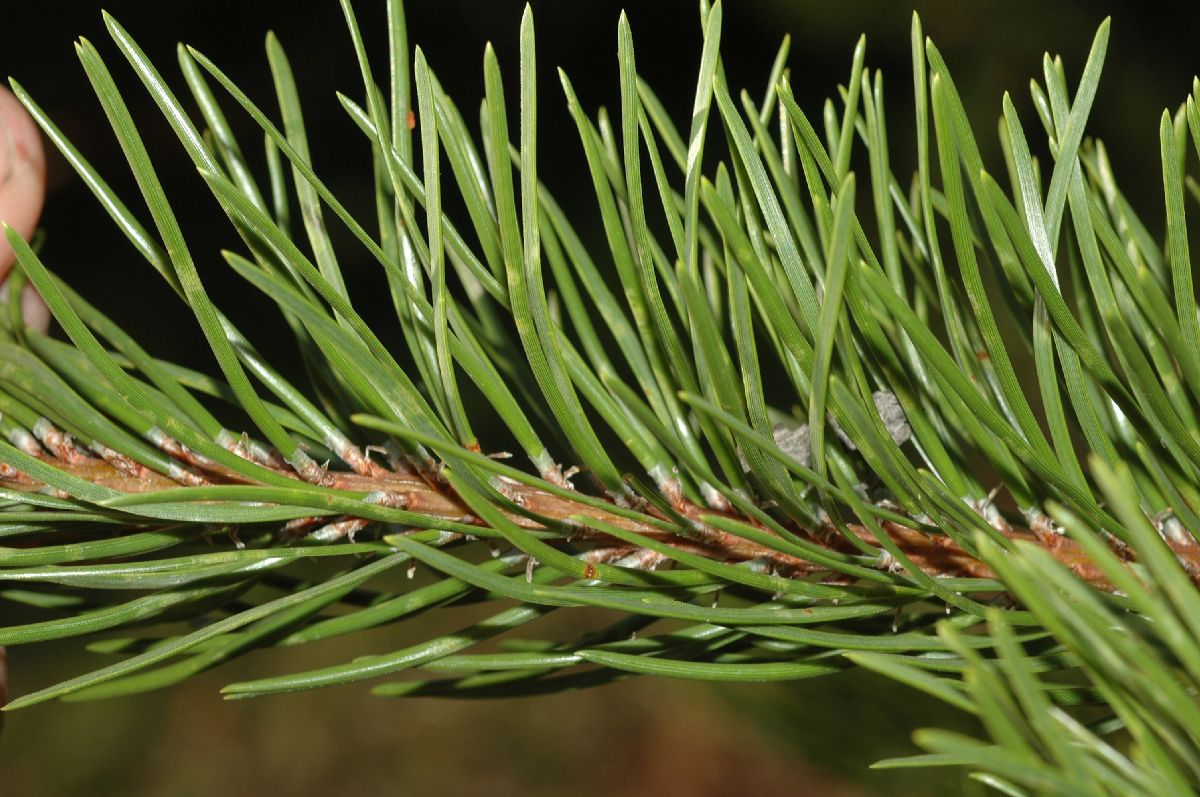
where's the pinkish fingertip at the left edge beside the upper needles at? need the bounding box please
[0,86,49,329]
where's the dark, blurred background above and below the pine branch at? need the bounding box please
[0,0,1196,796]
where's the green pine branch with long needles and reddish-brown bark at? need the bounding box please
[0,0,1200,795]
